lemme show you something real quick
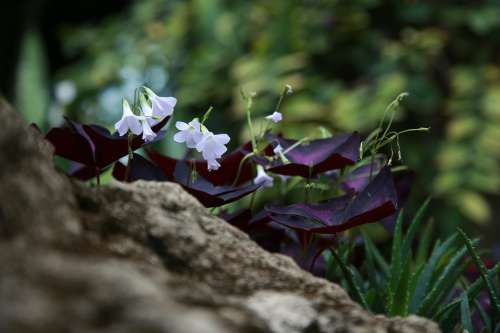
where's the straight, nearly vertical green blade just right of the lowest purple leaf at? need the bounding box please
[386,211,403,313]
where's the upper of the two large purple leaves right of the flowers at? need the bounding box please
[268,133,361,178]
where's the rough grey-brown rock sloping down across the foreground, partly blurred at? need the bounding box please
[0,105,438,333]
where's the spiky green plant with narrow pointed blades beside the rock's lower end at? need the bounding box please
[325,200,500,333]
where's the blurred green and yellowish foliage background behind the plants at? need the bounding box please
[1,0,500,242]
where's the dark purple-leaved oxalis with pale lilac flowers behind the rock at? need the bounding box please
[39,83,409,273]
